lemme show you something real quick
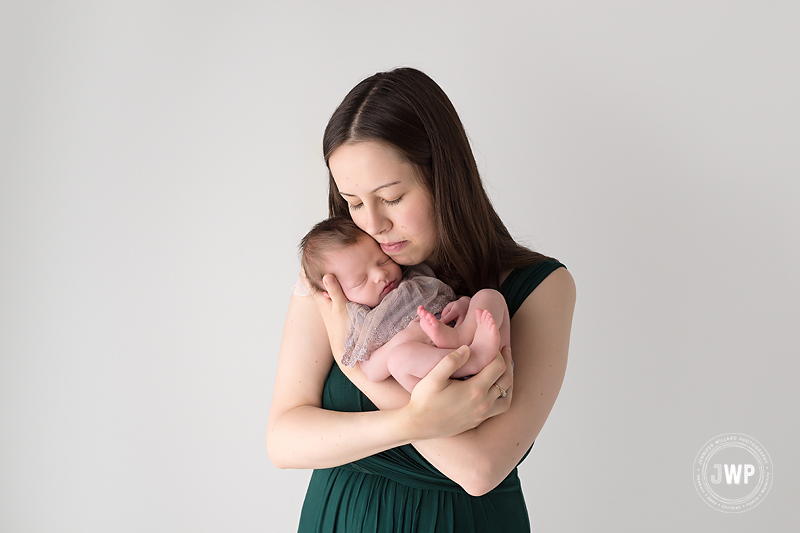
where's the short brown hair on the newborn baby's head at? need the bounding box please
[300,217,367,291]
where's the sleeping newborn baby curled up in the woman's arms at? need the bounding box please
[300,217,510,391]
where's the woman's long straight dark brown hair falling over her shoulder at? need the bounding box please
[322,68,549,295]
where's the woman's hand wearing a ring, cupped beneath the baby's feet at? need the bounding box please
[406,346,514,440]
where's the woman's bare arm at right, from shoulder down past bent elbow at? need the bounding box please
[414,268,575,495]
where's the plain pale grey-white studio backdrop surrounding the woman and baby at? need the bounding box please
[0,0,800,532]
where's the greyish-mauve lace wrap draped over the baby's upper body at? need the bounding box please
[342,264,456,366]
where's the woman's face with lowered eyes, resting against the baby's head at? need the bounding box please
[328,141,436,268]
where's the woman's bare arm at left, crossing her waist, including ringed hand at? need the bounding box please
[267,288,504,468]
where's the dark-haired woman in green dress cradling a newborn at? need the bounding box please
[267,68,575,533]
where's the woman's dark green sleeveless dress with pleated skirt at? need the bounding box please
[298,259,564,533]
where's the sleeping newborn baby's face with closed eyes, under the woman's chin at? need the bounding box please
[326,236,403,307]
